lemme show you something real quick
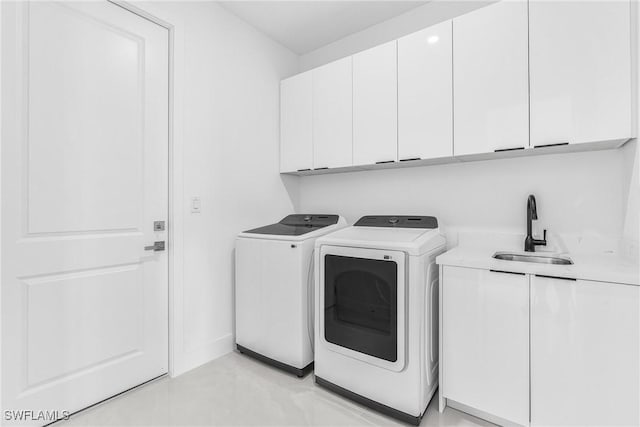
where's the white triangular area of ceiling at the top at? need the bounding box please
[218,0,427,55]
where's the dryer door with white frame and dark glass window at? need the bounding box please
[318,246,406,371]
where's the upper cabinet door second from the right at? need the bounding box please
[453,0,529,155]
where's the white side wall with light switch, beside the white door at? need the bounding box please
[135,1,298,375]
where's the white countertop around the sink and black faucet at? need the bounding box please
[436,246,640,286]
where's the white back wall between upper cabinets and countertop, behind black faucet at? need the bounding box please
[300,147,635,254]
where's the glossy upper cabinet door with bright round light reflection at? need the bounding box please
[398,21,453,160]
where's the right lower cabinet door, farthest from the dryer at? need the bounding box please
[531,277,640,426]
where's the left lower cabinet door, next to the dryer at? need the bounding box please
[440,267,529,425]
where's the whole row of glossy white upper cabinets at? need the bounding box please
[280,0,637,172]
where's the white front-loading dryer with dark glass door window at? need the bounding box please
[314,216,445,425]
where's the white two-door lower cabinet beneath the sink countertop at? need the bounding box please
[440,266,640,426]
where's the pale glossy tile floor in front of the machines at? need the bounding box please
[60,352,492,427]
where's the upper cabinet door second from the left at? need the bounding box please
[313,57,353,169]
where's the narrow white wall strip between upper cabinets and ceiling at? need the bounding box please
[300,0,496,71]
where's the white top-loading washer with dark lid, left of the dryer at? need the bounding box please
[235,215,347,377]
